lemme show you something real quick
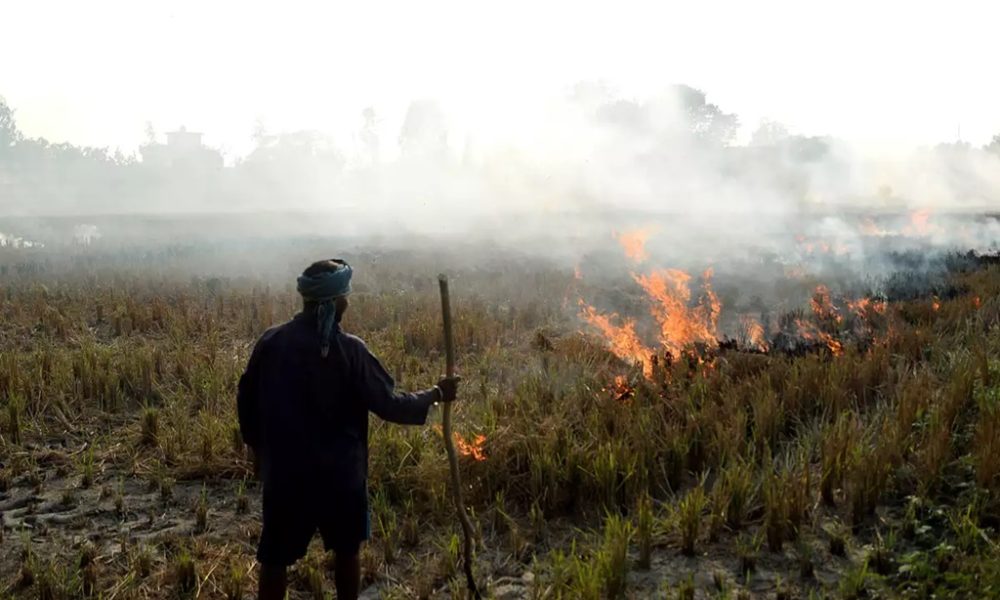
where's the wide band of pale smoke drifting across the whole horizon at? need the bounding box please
[0,83,1000,272]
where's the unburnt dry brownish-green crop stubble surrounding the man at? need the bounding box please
[0,247,1000,598]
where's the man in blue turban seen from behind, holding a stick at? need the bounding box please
[237,259,459,600]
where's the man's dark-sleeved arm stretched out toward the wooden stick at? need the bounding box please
[355,340,445,425]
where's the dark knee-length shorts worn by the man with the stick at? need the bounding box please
[257,485,371,567]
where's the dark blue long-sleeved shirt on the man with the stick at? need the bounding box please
[237,314,438,494]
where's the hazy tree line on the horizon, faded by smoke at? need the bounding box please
[0,83,1000,215]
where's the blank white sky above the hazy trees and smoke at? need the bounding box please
[0,0,1000,154]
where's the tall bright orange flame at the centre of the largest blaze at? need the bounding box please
[632,269,722,355]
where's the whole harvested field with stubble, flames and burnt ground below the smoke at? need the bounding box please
[0,231,1000,600]
